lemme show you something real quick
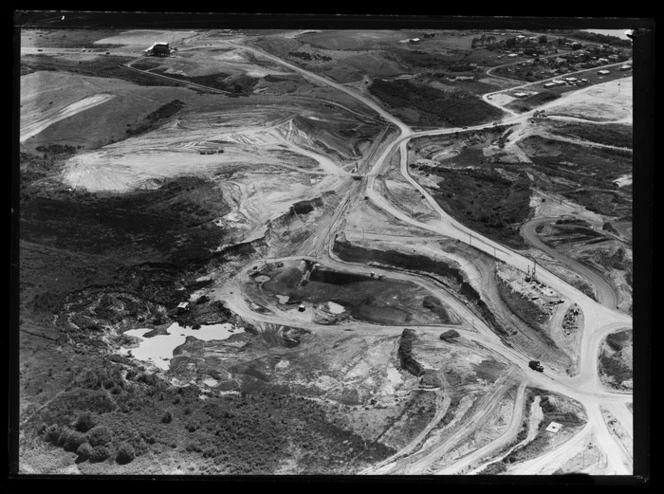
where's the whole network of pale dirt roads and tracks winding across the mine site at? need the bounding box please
[52,34,632,474]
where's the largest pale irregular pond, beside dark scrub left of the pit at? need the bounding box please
[122,323,244,370]
